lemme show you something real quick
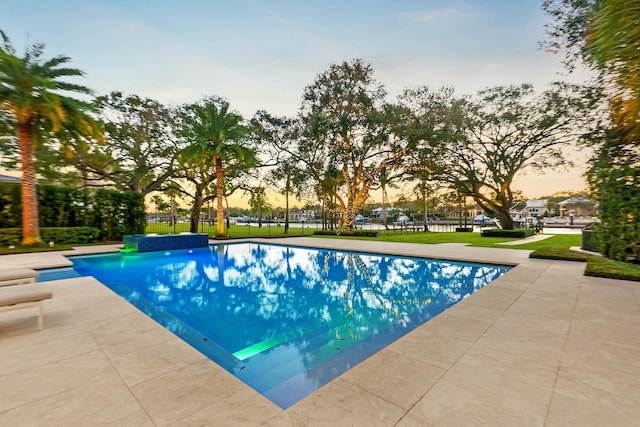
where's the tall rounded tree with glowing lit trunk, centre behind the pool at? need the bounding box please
[298,59,408,231]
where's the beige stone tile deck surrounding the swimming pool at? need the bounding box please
[0,238,640,427]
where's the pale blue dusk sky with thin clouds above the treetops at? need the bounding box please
[0,0,584,198]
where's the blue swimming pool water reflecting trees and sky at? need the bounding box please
[73,243,510,409]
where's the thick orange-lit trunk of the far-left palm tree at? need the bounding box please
[18,122,42,245]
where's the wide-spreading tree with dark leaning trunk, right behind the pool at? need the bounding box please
[409,84,592,229]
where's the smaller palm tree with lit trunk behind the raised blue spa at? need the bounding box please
[183,98,257,237]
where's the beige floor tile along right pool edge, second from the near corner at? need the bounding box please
[340,350,445,409]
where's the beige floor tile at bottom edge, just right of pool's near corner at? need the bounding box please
[286,379,405,427]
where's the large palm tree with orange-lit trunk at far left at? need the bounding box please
[0,31,97,245]
